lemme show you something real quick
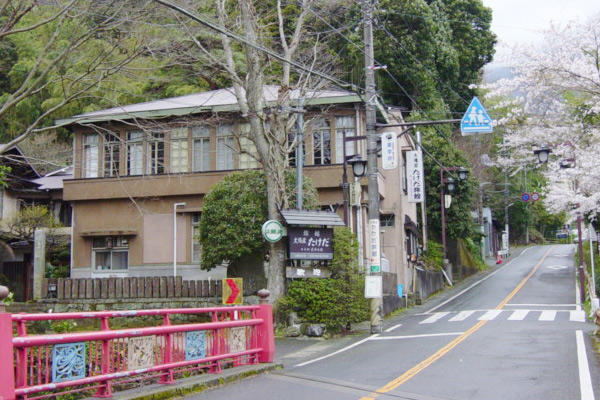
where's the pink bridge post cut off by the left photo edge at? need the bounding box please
[0,286,15,400]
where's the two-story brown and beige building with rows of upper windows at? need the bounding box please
[58,86,417,306]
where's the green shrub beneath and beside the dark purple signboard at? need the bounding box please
[277,228,369,331]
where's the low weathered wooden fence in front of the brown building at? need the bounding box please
[42,276,222,300]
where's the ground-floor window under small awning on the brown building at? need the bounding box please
[92,236,129,271]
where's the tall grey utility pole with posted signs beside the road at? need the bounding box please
[363,0,383,333]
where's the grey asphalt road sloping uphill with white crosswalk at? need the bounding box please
[188,245,600,400]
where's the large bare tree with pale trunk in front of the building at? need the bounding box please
[155,0,350,298]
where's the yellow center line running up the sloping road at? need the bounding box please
[359,246,554,400]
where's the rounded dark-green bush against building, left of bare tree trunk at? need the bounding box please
[199,170,318,270]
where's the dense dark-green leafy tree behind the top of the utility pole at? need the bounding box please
[340,0,496,114]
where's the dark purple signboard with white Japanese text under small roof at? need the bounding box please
[288,227,333,260]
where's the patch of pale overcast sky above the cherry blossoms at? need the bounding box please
[483,0,600,55]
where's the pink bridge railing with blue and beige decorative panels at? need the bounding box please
[0,288,275,400]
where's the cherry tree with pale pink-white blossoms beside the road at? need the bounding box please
[485,13,600,219]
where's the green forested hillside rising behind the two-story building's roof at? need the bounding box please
[0,0,495,173]
